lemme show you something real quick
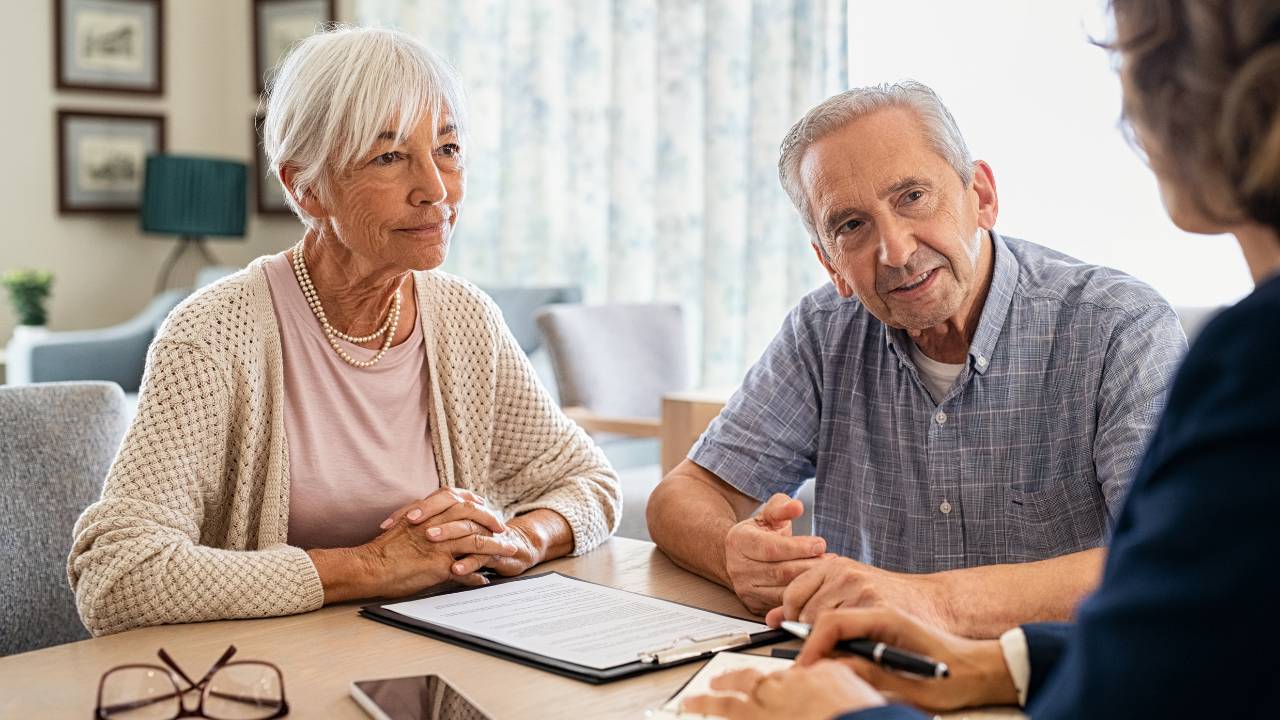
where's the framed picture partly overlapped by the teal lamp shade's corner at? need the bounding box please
[56,110,165,214]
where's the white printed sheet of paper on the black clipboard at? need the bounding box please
[383,573,769,670]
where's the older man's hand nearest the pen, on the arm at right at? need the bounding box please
[765,556,952,630]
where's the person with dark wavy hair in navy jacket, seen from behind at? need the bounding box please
[685,0,1280,720]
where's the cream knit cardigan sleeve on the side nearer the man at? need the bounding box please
[485,288,622,555]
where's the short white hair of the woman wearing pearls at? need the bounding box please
[262,26,467,227]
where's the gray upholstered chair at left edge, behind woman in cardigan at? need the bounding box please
[0,382,127,655]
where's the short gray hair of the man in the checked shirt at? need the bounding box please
[778,79,973,243]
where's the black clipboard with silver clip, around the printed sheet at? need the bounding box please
[360,573,791,684]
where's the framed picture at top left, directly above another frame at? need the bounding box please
[54,0,164,95]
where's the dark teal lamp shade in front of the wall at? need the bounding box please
[142,155,248,236]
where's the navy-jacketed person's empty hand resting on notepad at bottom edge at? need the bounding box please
[680,660,884,720]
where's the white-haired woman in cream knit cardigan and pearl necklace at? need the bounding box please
[68,28,621,635]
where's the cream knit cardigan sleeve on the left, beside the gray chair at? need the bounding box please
[68,340,324,635]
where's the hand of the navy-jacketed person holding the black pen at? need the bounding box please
[796,609,1018,711]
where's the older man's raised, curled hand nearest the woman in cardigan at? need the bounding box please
[724,493,827,615]
